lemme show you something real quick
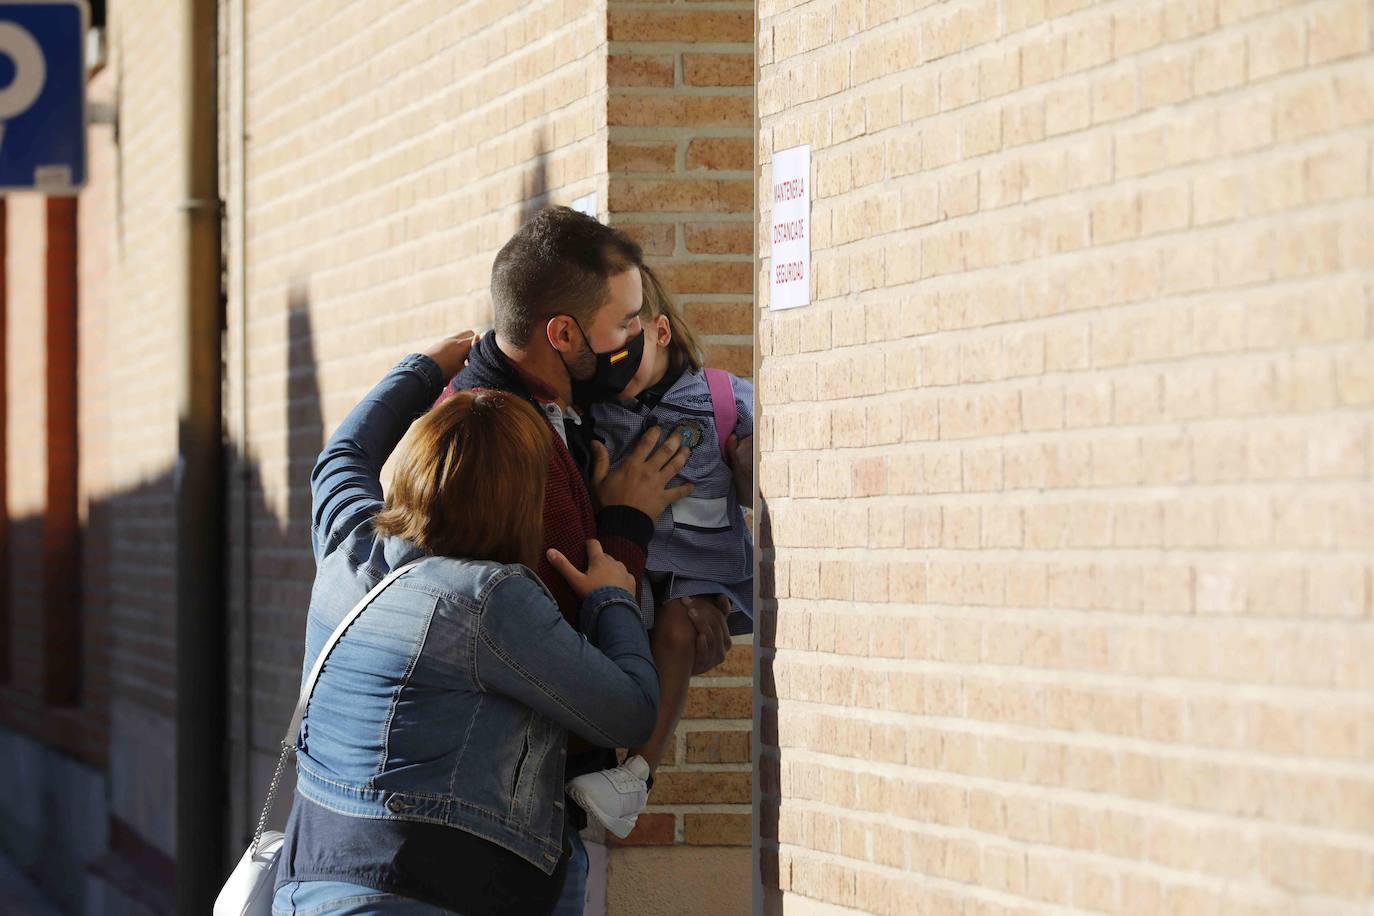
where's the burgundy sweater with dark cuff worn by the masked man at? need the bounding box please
[440,334,654,626]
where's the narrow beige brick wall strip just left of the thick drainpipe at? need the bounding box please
[101,0,184,857]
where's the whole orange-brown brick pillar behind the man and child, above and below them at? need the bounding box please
[606,7,754,900]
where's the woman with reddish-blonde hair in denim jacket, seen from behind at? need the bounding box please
[273,335,658,916]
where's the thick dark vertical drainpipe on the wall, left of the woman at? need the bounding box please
[174,0,228,916]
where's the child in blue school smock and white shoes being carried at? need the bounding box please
[567,268,754,838]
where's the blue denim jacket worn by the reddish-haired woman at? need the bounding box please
[297,356,658,872]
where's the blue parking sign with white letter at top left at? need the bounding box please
[0,0,87,194]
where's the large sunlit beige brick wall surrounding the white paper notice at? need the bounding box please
[758,0,1374,915]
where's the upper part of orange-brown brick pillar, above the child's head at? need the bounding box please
[607,0,754,376]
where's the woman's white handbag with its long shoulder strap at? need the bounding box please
[214,560,419,916]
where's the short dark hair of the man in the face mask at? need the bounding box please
[492,207,644,346]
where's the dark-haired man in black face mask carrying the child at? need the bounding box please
[451,207,730,916]
